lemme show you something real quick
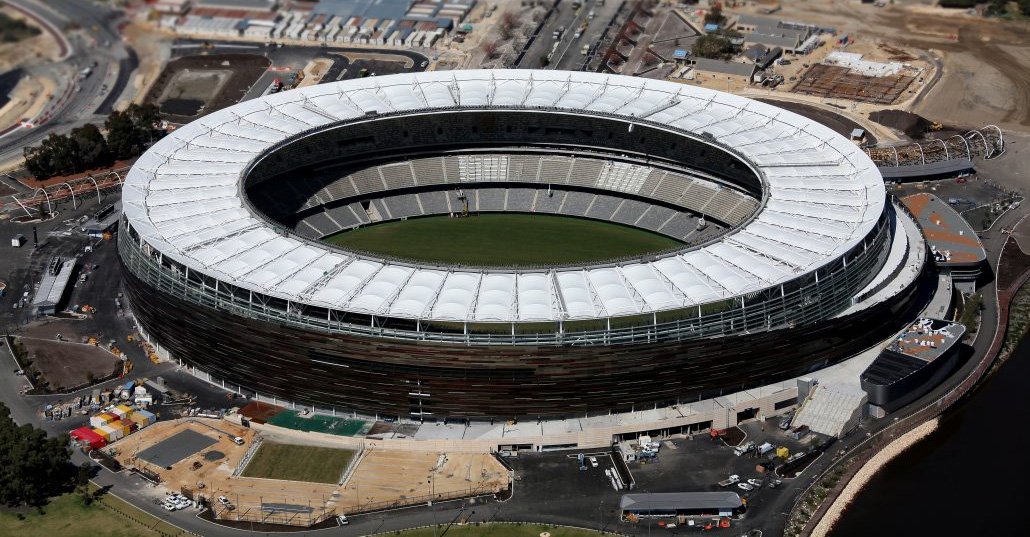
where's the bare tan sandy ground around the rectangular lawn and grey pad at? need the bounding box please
[121,418,508,519]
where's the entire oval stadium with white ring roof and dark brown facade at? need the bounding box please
[118,70,926,419]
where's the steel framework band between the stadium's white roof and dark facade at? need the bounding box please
[118,207,890,345]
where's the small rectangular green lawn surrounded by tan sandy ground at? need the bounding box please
[243,442,354,483]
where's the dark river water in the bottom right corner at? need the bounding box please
[830,338,1030,537]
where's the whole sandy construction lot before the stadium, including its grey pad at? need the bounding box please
[104,416,510,527]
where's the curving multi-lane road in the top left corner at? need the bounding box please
[0,0,138,163]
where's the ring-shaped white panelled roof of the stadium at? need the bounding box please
[123,70,886,323]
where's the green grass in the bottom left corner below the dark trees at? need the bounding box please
[0,486,182,537]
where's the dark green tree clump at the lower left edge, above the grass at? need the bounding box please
[0,403,74,507]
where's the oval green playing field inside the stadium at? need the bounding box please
[325,213,680,267]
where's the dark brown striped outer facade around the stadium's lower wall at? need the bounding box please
[123,253,935,419]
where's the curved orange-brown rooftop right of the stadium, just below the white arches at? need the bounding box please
[901,194,987,267]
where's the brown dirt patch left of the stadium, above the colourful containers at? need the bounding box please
[18,337,122,392]
